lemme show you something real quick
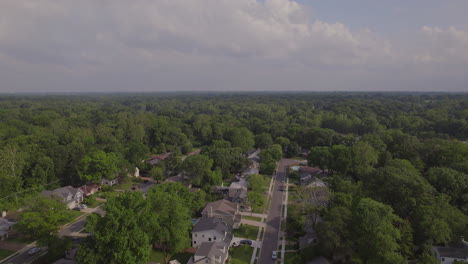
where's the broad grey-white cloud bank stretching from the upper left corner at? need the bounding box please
[0,0,390,68]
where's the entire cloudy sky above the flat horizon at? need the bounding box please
[0,0,468,93]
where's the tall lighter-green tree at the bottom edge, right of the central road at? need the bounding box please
[352,198,405,264]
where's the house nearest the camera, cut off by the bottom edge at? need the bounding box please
[187,242,229,264]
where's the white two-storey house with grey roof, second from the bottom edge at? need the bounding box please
[192,217,233,248]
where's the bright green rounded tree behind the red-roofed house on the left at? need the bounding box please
[80,150,122,182]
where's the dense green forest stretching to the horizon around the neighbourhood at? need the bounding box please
[0,93,468,263]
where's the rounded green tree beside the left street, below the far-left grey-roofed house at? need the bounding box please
[15,195,71,245]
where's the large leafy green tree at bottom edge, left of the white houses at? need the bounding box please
[76,192,152,264]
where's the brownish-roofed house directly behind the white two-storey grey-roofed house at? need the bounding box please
[202,199,241,229]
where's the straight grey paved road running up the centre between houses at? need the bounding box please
[257,159,296,264]
